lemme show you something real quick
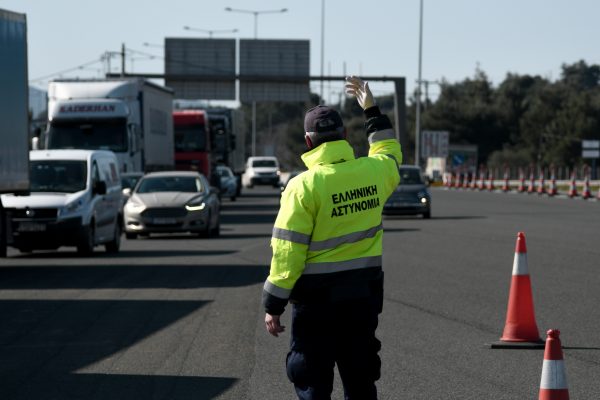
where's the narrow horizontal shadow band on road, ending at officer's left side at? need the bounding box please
[0,264,268,290]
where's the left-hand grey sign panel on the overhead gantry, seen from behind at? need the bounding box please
[165,38,236,100]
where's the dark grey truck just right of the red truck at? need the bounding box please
[207,108,246,196]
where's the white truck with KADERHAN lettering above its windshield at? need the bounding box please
[43,78,175,172]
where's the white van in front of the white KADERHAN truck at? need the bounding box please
[2,150,123,254]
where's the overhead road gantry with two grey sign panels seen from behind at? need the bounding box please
[107,38,408,157]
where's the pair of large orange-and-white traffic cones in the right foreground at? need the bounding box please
[492,232,569,400]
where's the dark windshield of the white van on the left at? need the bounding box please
[29,160,87,193]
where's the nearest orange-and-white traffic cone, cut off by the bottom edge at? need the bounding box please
[538,329,569,400]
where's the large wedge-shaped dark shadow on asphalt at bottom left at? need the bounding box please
[0,300,236,400]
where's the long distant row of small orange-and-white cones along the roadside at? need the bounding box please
[445,170,600,200]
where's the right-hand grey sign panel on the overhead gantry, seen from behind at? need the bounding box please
[240,39,310,102]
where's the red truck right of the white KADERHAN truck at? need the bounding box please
[173,110,213,179]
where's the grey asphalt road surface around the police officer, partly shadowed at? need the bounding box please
[0,189,600,400]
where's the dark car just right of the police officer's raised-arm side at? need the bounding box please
[383,165,431,218]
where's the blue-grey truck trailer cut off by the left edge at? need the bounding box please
[0,9,29,257]
